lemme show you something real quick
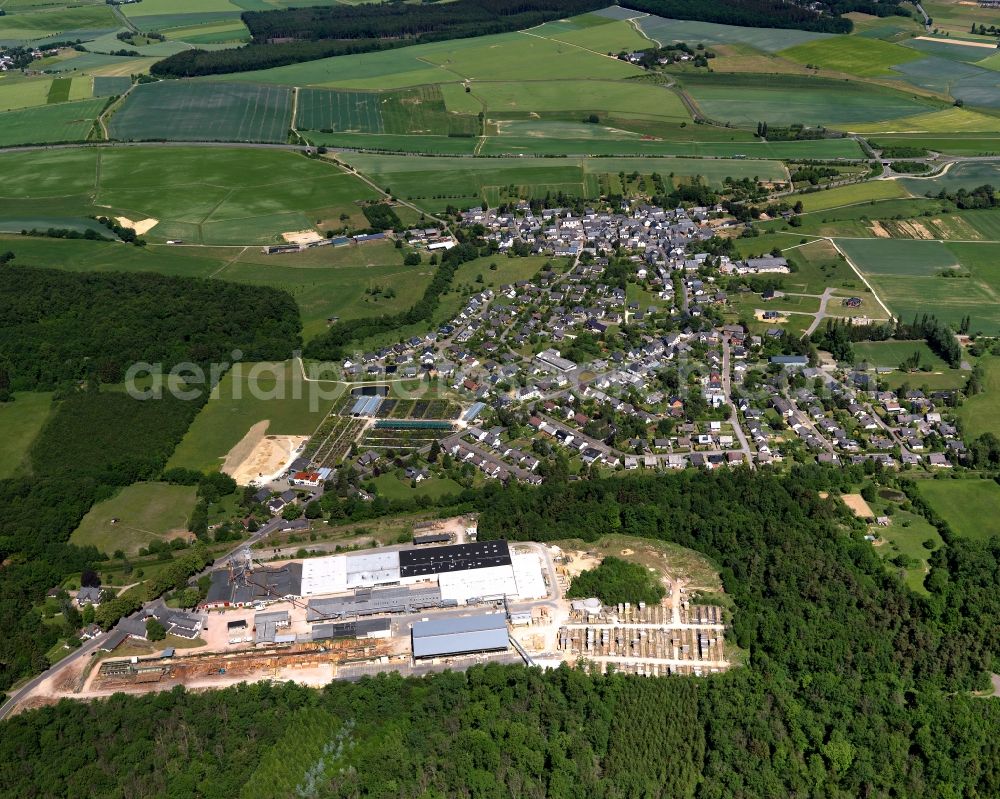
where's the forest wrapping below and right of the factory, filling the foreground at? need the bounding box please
[0,468,1000,799]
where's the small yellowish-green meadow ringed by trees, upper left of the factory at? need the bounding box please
[70,483,197,555]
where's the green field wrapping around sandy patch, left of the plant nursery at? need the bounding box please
[167,361,336,472]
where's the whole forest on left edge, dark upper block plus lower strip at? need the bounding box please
[0,264,299,690]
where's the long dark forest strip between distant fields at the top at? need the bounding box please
[151,0,606,77]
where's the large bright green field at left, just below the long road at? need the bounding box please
[0,144,378,245]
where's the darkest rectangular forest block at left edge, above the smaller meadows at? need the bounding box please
[0,264,301,390]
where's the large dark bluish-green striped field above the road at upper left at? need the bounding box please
[110,81,292,143]
